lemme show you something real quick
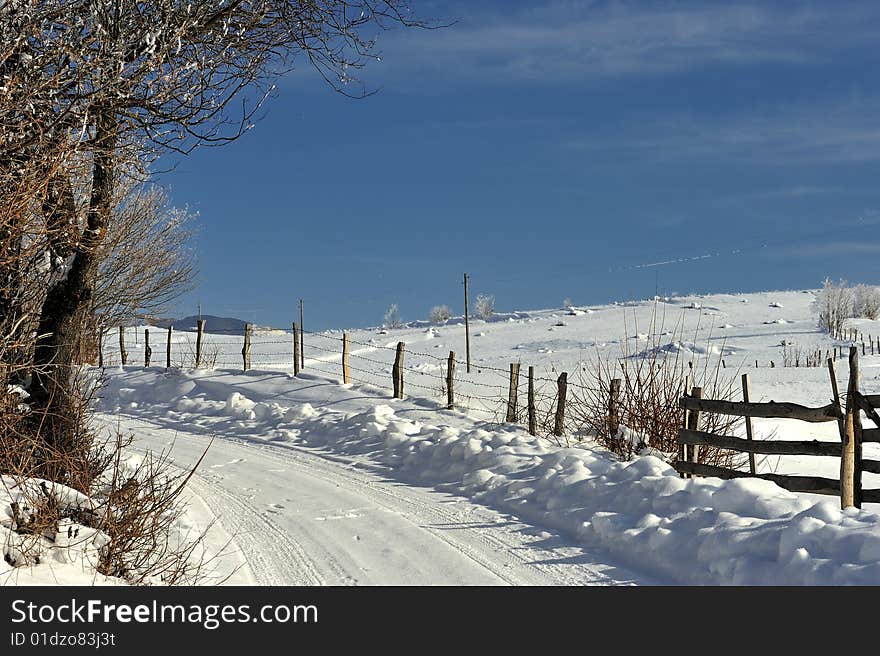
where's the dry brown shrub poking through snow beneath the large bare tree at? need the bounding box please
[0,374,219,585]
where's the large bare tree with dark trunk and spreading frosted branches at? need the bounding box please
[0,0,434,474]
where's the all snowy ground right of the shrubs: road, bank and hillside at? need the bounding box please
[6,292,880,584]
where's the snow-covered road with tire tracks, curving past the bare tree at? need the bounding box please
[106,417,652,585]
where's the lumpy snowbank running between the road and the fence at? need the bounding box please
[98,370,880,585]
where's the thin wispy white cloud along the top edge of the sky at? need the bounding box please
[380,1,880,83]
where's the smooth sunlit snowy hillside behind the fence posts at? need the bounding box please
[105,290,880,487]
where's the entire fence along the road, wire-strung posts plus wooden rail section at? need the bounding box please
[111,320,880,507]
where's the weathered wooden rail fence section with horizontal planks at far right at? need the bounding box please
[675,346,880,508]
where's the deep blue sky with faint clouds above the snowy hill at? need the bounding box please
[162,0,880,329]
